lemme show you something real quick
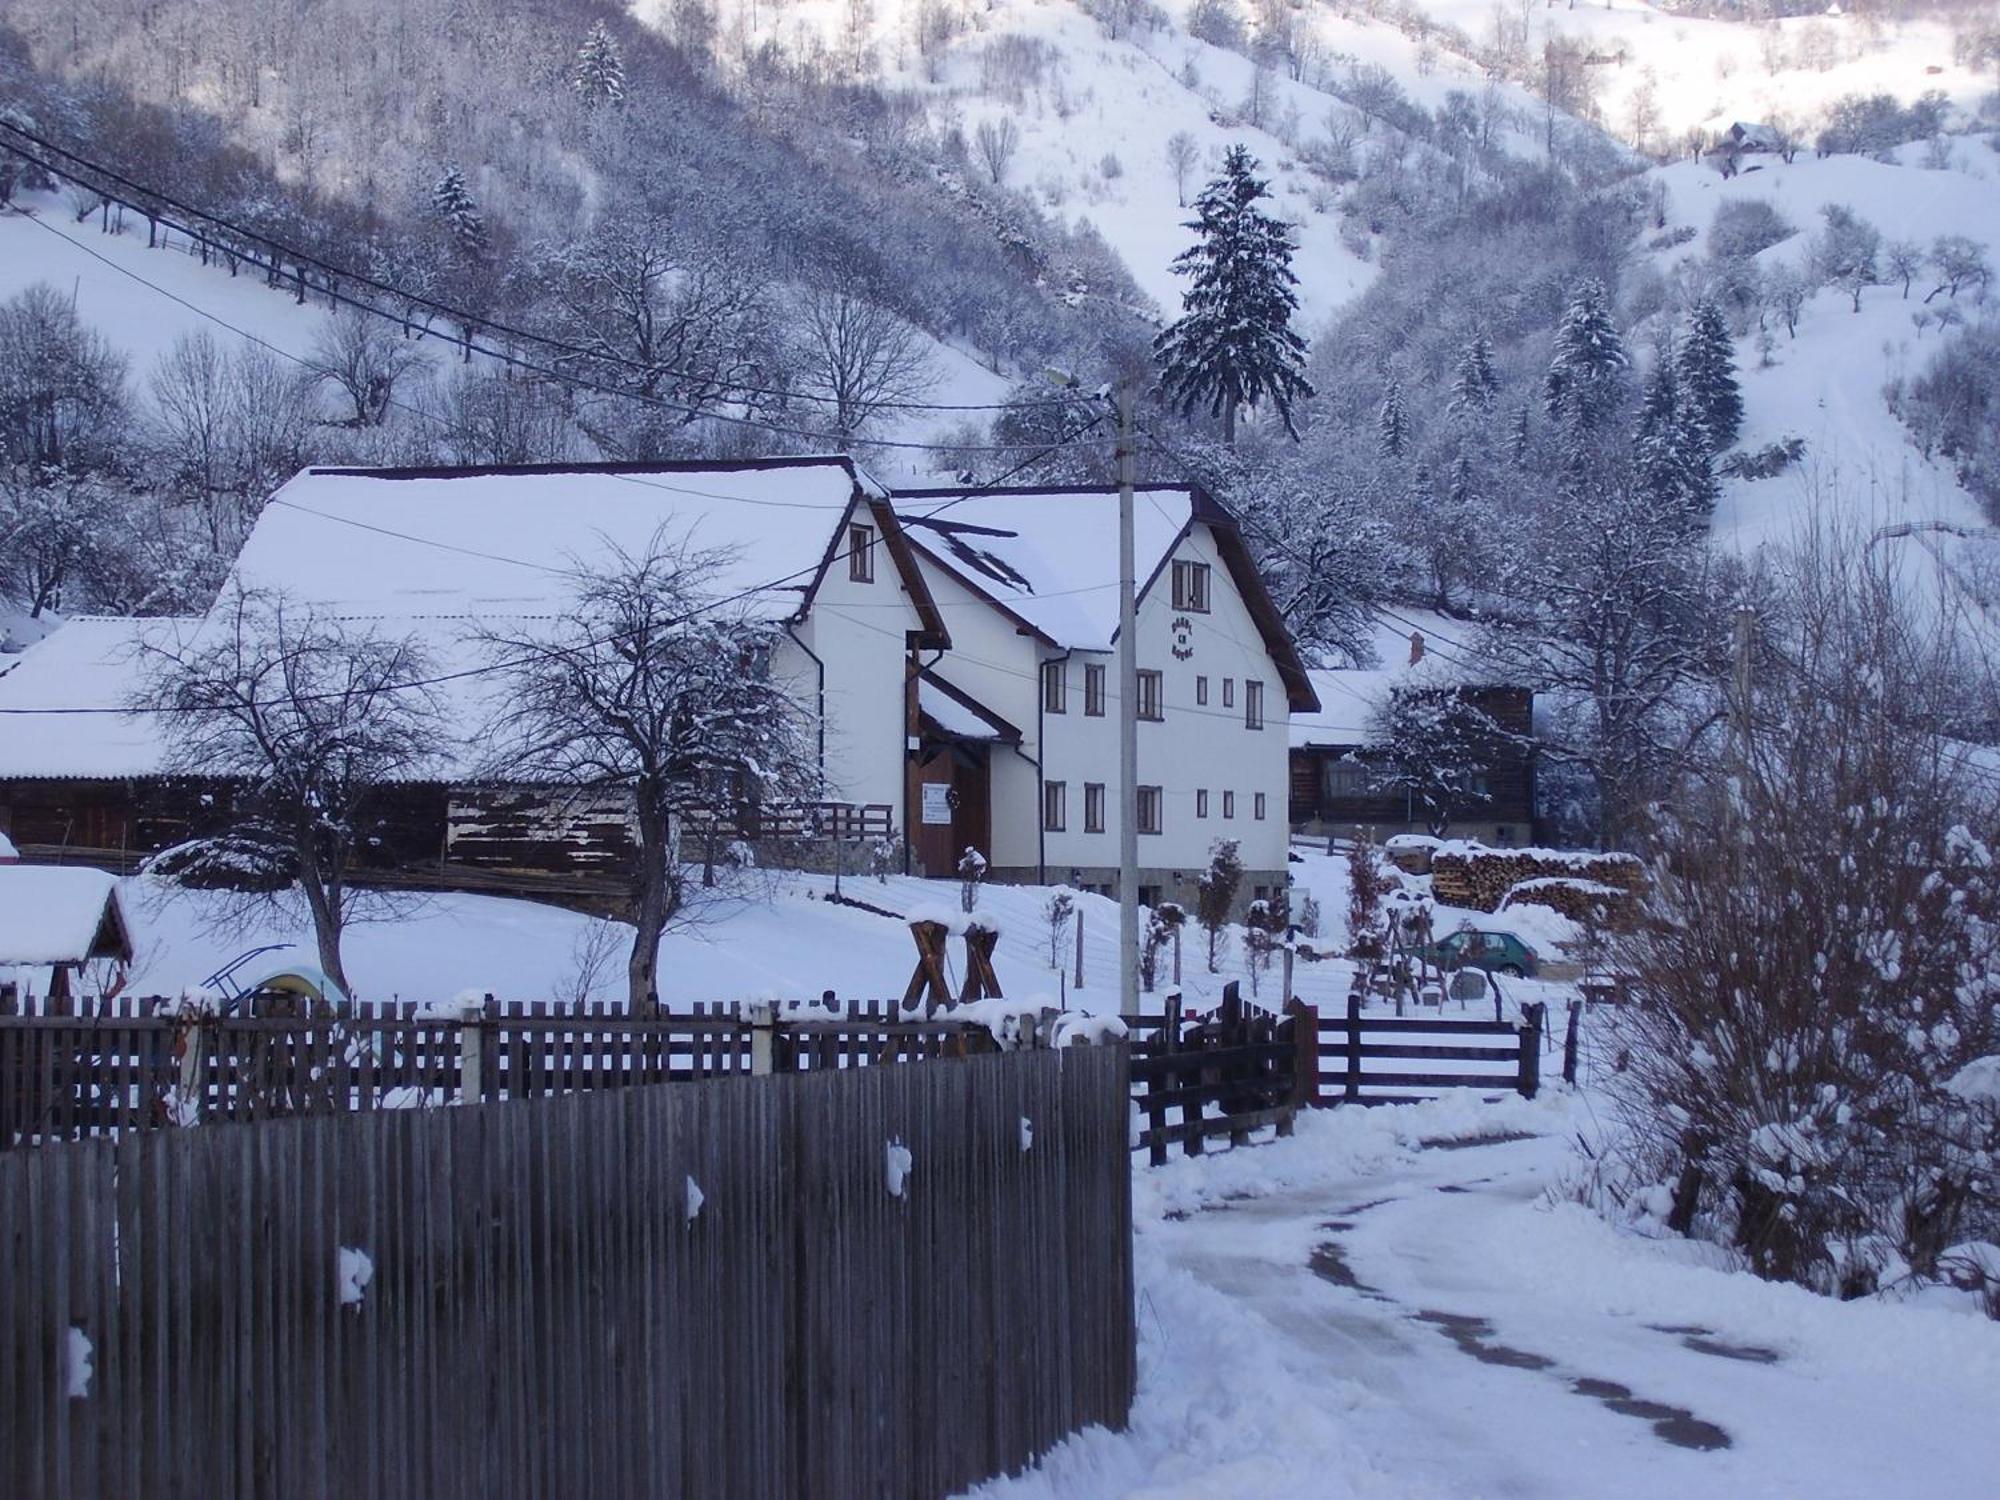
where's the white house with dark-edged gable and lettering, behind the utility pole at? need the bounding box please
[894,486,1318,902]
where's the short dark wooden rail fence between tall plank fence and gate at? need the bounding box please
[1124,984,1318,1166]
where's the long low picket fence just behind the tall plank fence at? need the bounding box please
[0,998,1048,1150]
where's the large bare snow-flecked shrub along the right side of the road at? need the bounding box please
[1608,538,2000,1296]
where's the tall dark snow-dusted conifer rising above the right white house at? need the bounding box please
[1154,146,1312,442]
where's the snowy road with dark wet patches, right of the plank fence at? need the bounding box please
[972,1100,2000,1500]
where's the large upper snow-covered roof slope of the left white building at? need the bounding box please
[232,458,880,620]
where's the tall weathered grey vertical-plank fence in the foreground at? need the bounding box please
[0,1044,1136,1500]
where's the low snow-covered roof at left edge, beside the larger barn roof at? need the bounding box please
[0,618,178,778]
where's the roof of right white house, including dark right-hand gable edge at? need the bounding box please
[894,484,1316,712]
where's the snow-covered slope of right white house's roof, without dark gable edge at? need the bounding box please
[894,486,1194,652]
